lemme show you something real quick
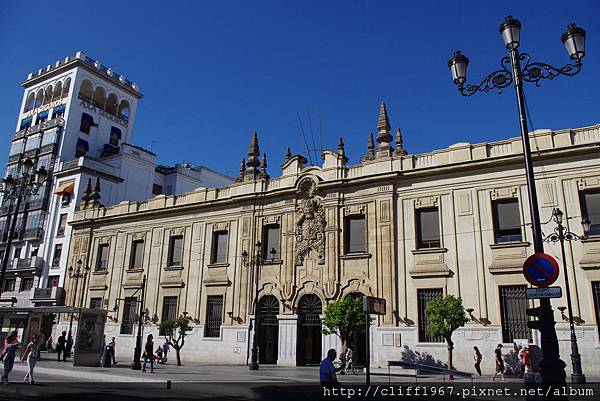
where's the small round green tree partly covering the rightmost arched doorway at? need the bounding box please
[321,294,366,355]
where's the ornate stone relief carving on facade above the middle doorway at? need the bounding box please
[294,178,327,266]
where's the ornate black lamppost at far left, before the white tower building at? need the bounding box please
[0,159,48,294]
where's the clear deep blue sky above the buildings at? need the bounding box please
[0,0,600,176]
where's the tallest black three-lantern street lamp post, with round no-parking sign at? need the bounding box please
[448,16,585,384]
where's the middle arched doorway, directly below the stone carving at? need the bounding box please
[296,294,323,365]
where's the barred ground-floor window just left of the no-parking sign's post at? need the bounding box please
[498,285,532,343]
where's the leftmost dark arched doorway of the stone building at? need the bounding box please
[257,295,279,364]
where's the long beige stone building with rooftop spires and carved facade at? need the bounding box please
[64,104,600,373]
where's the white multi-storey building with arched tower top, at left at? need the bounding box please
[0,52,233,324]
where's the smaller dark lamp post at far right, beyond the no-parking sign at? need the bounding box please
[544,208,591,384]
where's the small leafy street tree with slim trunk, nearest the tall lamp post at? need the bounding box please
[425,295,468,379]
